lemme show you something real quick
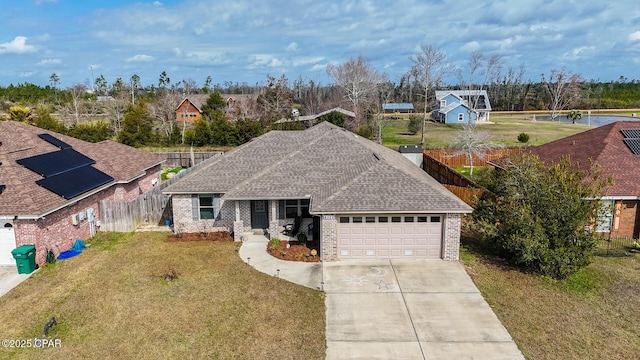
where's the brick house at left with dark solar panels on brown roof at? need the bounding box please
[0,121,164,265]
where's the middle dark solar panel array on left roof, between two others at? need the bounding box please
[16,149,95,177]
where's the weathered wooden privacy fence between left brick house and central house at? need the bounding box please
[99,153,222,232]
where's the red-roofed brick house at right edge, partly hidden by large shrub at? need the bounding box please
[531,121,640,239]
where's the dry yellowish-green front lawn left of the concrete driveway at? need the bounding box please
[0,232,326,359]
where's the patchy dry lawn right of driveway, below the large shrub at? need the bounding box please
[461,243,640,359]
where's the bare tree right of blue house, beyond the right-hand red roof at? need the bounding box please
[542,69,583,121]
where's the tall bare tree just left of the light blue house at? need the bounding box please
[409,44,454,144]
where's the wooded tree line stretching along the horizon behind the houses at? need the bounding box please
[0,45,640,146]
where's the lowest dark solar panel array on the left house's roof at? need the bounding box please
[36,166,113,199]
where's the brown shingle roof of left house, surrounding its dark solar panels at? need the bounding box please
[0,121,164,216]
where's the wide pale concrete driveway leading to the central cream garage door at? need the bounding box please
[323,260,524,359]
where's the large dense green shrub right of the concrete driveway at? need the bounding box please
[473,154,607,278]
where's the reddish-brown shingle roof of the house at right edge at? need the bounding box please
[531,121,640,196]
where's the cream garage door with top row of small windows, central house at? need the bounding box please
[338,215,443,260]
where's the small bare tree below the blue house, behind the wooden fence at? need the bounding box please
[453,122,500,177]
